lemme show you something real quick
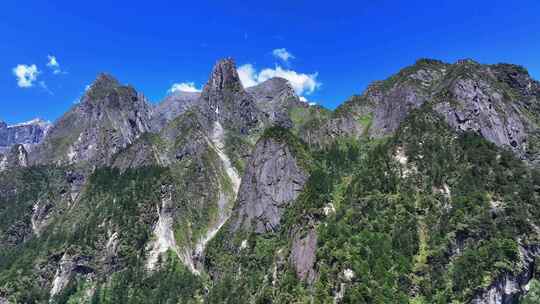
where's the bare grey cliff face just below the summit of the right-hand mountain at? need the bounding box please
[434,61,540,162]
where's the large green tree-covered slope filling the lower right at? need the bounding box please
[206,106,540,303]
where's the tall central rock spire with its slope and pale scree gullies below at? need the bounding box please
[113,60,254,274]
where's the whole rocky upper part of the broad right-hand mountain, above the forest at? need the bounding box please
[336,59,540,163]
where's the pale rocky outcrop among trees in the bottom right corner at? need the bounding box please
[471,246,540,304]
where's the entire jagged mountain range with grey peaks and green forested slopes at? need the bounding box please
[0,59,540,304]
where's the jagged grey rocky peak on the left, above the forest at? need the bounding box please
[31,74,152,165]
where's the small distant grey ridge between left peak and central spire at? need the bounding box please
[152,91,201,132]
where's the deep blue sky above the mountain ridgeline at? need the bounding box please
[0,0,540,123]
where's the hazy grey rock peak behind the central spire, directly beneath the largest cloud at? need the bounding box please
[246,77,309,127]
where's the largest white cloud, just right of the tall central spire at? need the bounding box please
[238,64,321,96]
